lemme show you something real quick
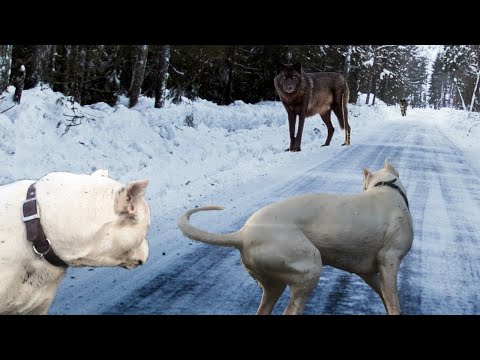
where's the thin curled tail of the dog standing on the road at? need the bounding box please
[178,205,242,249]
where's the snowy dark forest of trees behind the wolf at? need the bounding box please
[0,45,480,112]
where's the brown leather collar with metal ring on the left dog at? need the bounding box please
[23,183,68,267]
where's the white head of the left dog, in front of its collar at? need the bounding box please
[37,170,150,269]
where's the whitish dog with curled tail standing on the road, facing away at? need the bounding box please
[178,160,413,314]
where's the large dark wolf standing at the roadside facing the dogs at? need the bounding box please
[274,63,350,151]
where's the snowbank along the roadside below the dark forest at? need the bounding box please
[0,86,480,229]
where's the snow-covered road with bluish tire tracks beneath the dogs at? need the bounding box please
[50,111,480,314]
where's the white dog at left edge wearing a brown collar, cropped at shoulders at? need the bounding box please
[0,170,150,314]
